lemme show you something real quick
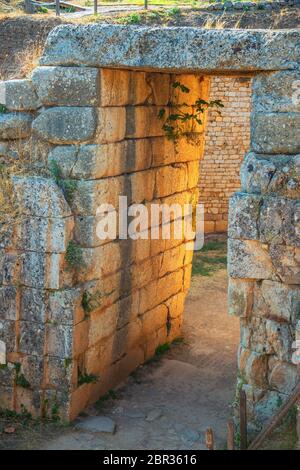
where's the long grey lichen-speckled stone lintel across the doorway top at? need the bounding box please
[41,25,300,73]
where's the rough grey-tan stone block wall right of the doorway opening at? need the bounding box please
[228,72,300,427]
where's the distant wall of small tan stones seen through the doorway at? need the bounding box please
[199,76,251,233]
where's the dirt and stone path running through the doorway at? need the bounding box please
[0,237,239,450]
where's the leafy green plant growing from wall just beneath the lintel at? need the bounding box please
[158,81,224,146]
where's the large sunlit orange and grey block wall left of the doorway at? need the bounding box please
[0,66,209,419]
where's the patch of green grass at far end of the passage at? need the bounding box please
[192,241,227,276]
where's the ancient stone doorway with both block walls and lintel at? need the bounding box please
[0,25,300,434]
